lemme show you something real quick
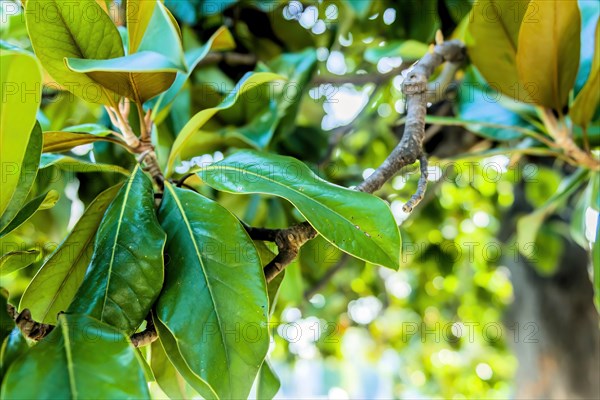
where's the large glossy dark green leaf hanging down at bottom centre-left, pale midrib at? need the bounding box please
[156,183,269,398]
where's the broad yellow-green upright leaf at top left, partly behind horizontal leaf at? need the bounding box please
[25,0,124,104]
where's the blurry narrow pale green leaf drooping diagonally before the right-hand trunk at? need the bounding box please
[517,169,589,254]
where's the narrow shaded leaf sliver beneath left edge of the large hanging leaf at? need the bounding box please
[153,318,219,399]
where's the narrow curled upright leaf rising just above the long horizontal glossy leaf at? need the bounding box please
[165,72,283,177]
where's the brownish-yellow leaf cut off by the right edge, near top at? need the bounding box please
[569,24,600,128]
